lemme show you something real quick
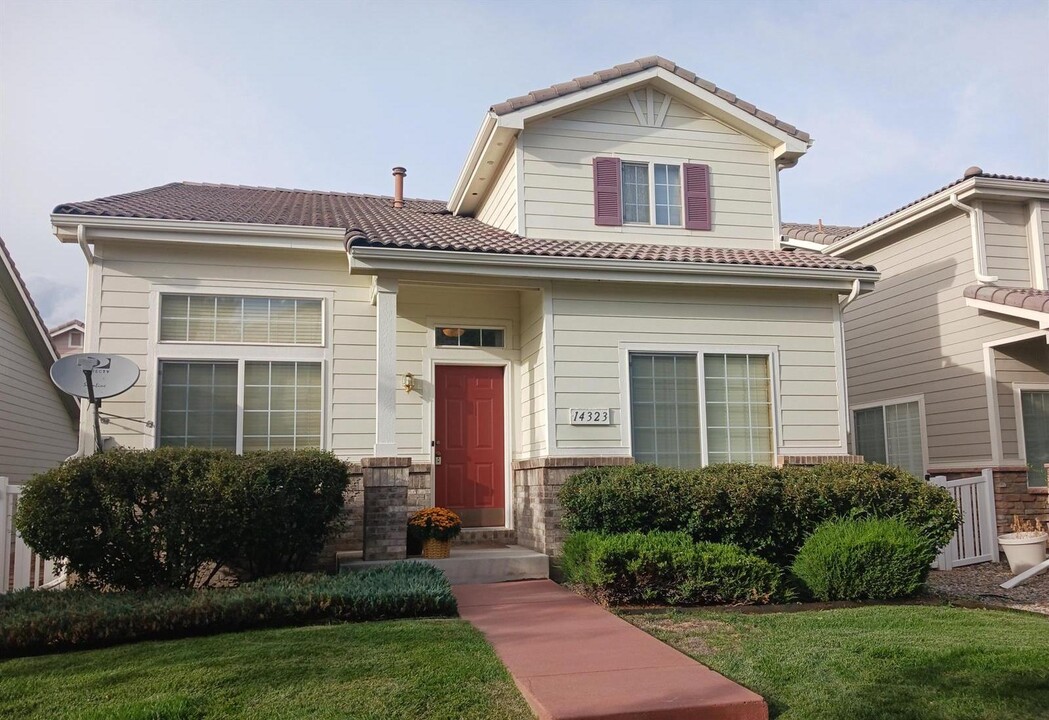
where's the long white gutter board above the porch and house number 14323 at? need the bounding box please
[349,247,880,293]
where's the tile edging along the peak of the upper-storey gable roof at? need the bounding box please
[491,55,812,143]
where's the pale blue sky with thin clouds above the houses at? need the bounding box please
[0,0,1049,323]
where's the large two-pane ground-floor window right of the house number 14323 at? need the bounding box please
[629,353,774,467]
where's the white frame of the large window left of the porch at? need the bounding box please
[144,285,335,453]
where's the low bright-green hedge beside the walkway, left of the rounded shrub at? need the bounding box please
[562,532,783,605]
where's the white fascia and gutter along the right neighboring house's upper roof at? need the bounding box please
[823,177,1049,256]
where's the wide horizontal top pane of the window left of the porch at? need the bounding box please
[160,295,322,345]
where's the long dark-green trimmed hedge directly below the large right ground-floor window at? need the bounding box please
[558,463,959,567]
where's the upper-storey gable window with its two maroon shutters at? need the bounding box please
[594,157,712,230]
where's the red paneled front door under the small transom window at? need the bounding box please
[433,365,506,528]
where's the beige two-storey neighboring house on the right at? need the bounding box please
[784,168,1049,529]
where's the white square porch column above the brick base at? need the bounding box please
[374,278,399,458]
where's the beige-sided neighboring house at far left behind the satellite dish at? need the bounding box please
[0,239,80,484]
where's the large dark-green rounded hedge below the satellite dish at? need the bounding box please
[15,447,349,589]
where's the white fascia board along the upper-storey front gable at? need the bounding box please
[498,66,809,157]
